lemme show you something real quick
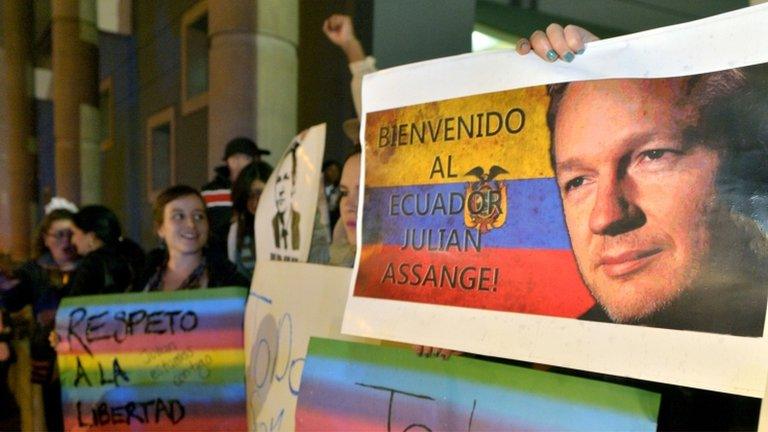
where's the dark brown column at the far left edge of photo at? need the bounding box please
[0,0,35,261]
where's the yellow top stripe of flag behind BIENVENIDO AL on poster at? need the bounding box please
[365,86,554,187]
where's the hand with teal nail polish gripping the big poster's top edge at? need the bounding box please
[516,23,600,63]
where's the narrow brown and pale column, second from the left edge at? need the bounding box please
[51,0,101,203]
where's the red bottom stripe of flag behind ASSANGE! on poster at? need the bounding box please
[355,245,594,318]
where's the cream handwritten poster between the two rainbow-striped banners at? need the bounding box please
[245,261,370,431]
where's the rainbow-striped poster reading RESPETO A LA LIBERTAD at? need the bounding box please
[56,288,247,431]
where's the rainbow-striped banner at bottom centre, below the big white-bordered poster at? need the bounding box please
[296,338,661,431]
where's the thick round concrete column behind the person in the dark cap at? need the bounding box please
[208,0,298,170]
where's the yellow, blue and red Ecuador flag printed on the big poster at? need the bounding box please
[354,86,594,317]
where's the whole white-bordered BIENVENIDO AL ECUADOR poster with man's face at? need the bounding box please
[343,6,768,397]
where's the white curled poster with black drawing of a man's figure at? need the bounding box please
[255,124,327,262]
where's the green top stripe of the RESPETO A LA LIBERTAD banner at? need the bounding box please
[59,287,248,308]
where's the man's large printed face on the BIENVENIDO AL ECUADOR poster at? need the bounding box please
[554,79,720,322]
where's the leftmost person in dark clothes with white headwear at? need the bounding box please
[0,198,80,430]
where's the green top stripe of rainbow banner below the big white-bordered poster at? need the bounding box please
[310,338,661,416]
